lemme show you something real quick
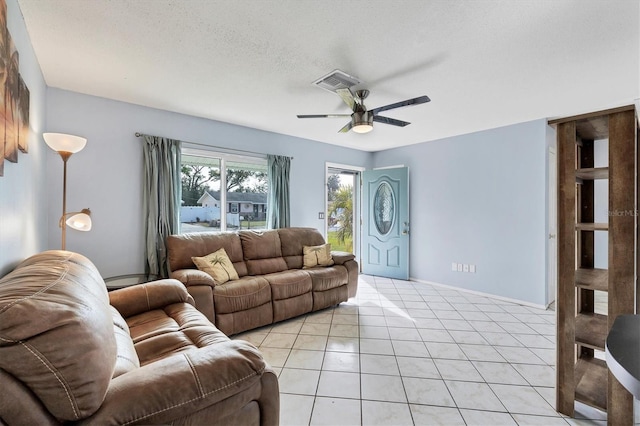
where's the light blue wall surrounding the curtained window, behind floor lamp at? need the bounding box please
[47,88,373,277]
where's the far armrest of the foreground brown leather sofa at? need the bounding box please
[109,279,194,318]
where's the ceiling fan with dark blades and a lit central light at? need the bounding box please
[298,88,431,133]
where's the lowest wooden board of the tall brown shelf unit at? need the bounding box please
[575,358,608,411]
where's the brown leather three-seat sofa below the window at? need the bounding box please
[167,228,358,335]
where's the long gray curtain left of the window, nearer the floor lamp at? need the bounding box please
[142,135,181,277]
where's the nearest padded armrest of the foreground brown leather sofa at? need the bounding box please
[81,340,278,424]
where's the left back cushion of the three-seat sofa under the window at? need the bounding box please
[167,232,247,277]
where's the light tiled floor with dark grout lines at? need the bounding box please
[234,275,638,425]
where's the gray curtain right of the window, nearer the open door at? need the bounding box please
[267,155,291,229]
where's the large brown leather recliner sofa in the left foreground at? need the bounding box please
[0,251,279,425]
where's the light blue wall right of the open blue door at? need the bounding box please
[374,120,548,305]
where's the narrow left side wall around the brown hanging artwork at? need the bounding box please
[0,0,47,276]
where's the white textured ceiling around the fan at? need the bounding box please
[18,0,640,151]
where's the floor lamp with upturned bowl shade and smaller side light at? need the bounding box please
[42,133,91,250]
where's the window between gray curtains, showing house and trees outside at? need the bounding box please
[180,149,267,233]
